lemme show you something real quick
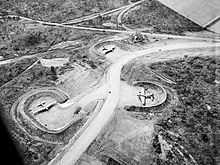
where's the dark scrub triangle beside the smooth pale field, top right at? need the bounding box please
[123,0,202,34]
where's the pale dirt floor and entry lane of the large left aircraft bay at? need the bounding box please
[25,69,106,130]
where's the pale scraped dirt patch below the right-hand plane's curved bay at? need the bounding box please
[91,109,155,161]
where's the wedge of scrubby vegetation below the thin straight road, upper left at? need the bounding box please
[0,15,113,59]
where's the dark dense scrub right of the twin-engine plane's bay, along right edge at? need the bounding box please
[150,57,220,165]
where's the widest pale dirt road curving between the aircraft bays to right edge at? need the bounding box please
[49,42,220,165]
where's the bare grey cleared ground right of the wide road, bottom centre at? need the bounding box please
[85,109,155,164]
